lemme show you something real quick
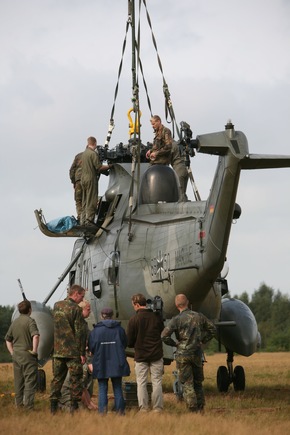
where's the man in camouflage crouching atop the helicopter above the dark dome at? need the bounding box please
[146,115,172,165]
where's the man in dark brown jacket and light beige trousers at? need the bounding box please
[127,293,164,412]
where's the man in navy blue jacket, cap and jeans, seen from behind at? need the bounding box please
[89,308,130,414]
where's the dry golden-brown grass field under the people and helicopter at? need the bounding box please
[0,353,290,435]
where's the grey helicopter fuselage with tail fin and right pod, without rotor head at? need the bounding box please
[36,123,290,359]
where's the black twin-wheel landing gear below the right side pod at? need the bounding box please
[217,350,246,393]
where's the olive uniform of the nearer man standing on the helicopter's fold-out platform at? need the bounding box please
[81,148,102,225]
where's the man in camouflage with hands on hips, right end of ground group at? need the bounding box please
[161,294,216,412]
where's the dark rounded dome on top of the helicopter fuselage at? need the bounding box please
[139,165,179,204]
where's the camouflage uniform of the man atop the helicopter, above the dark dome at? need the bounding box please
[150,124,172,165]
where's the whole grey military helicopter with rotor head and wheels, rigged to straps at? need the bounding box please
[15,0,290,391]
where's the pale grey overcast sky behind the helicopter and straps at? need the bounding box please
[0,0,290,305]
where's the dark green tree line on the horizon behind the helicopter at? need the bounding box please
[0,283,290,362]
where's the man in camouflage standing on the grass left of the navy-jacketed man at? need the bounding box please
[50,284,86,414]
